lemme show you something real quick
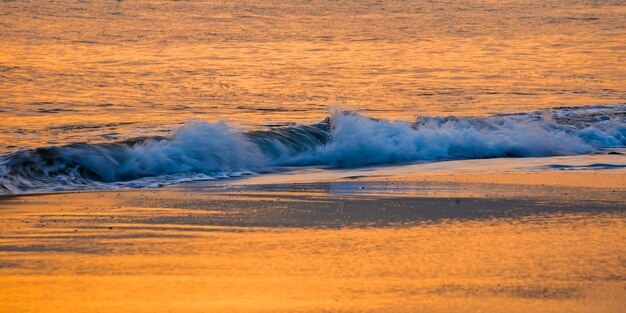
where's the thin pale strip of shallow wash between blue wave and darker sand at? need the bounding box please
[0,148,626,199]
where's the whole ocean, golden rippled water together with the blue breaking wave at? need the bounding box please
[0,0,626,193]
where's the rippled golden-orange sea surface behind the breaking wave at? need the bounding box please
[0,0,626,153]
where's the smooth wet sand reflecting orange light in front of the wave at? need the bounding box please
[0,164,626,312]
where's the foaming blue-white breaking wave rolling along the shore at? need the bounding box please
[0,105,626,193]
